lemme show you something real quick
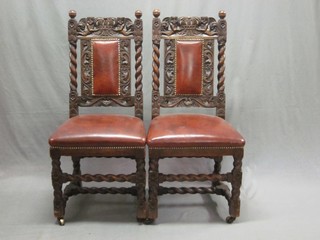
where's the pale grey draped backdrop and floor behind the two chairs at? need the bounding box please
[0,0,320,239]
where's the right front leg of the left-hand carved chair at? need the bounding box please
[136,158,147,222]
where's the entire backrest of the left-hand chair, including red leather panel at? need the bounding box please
[69,13,143,118]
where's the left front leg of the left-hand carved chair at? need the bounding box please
[51,151,66,225]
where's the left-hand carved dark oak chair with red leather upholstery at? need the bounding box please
[49,11,147,225]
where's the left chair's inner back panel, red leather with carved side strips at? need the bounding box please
[81,38,131,99]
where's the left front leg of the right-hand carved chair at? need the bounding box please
[147,158,159,223]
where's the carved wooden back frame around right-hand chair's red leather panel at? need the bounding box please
[153,13,227,111]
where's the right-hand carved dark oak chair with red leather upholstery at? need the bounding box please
[147,10,245,223]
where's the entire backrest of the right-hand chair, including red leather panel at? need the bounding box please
[152,13,226,118]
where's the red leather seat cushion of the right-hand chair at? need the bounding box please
[147,114,245,147]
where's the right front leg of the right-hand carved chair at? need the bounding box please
[226,150,243,223]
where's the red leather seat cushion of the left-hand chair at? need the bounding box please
[49,115,146,147]
